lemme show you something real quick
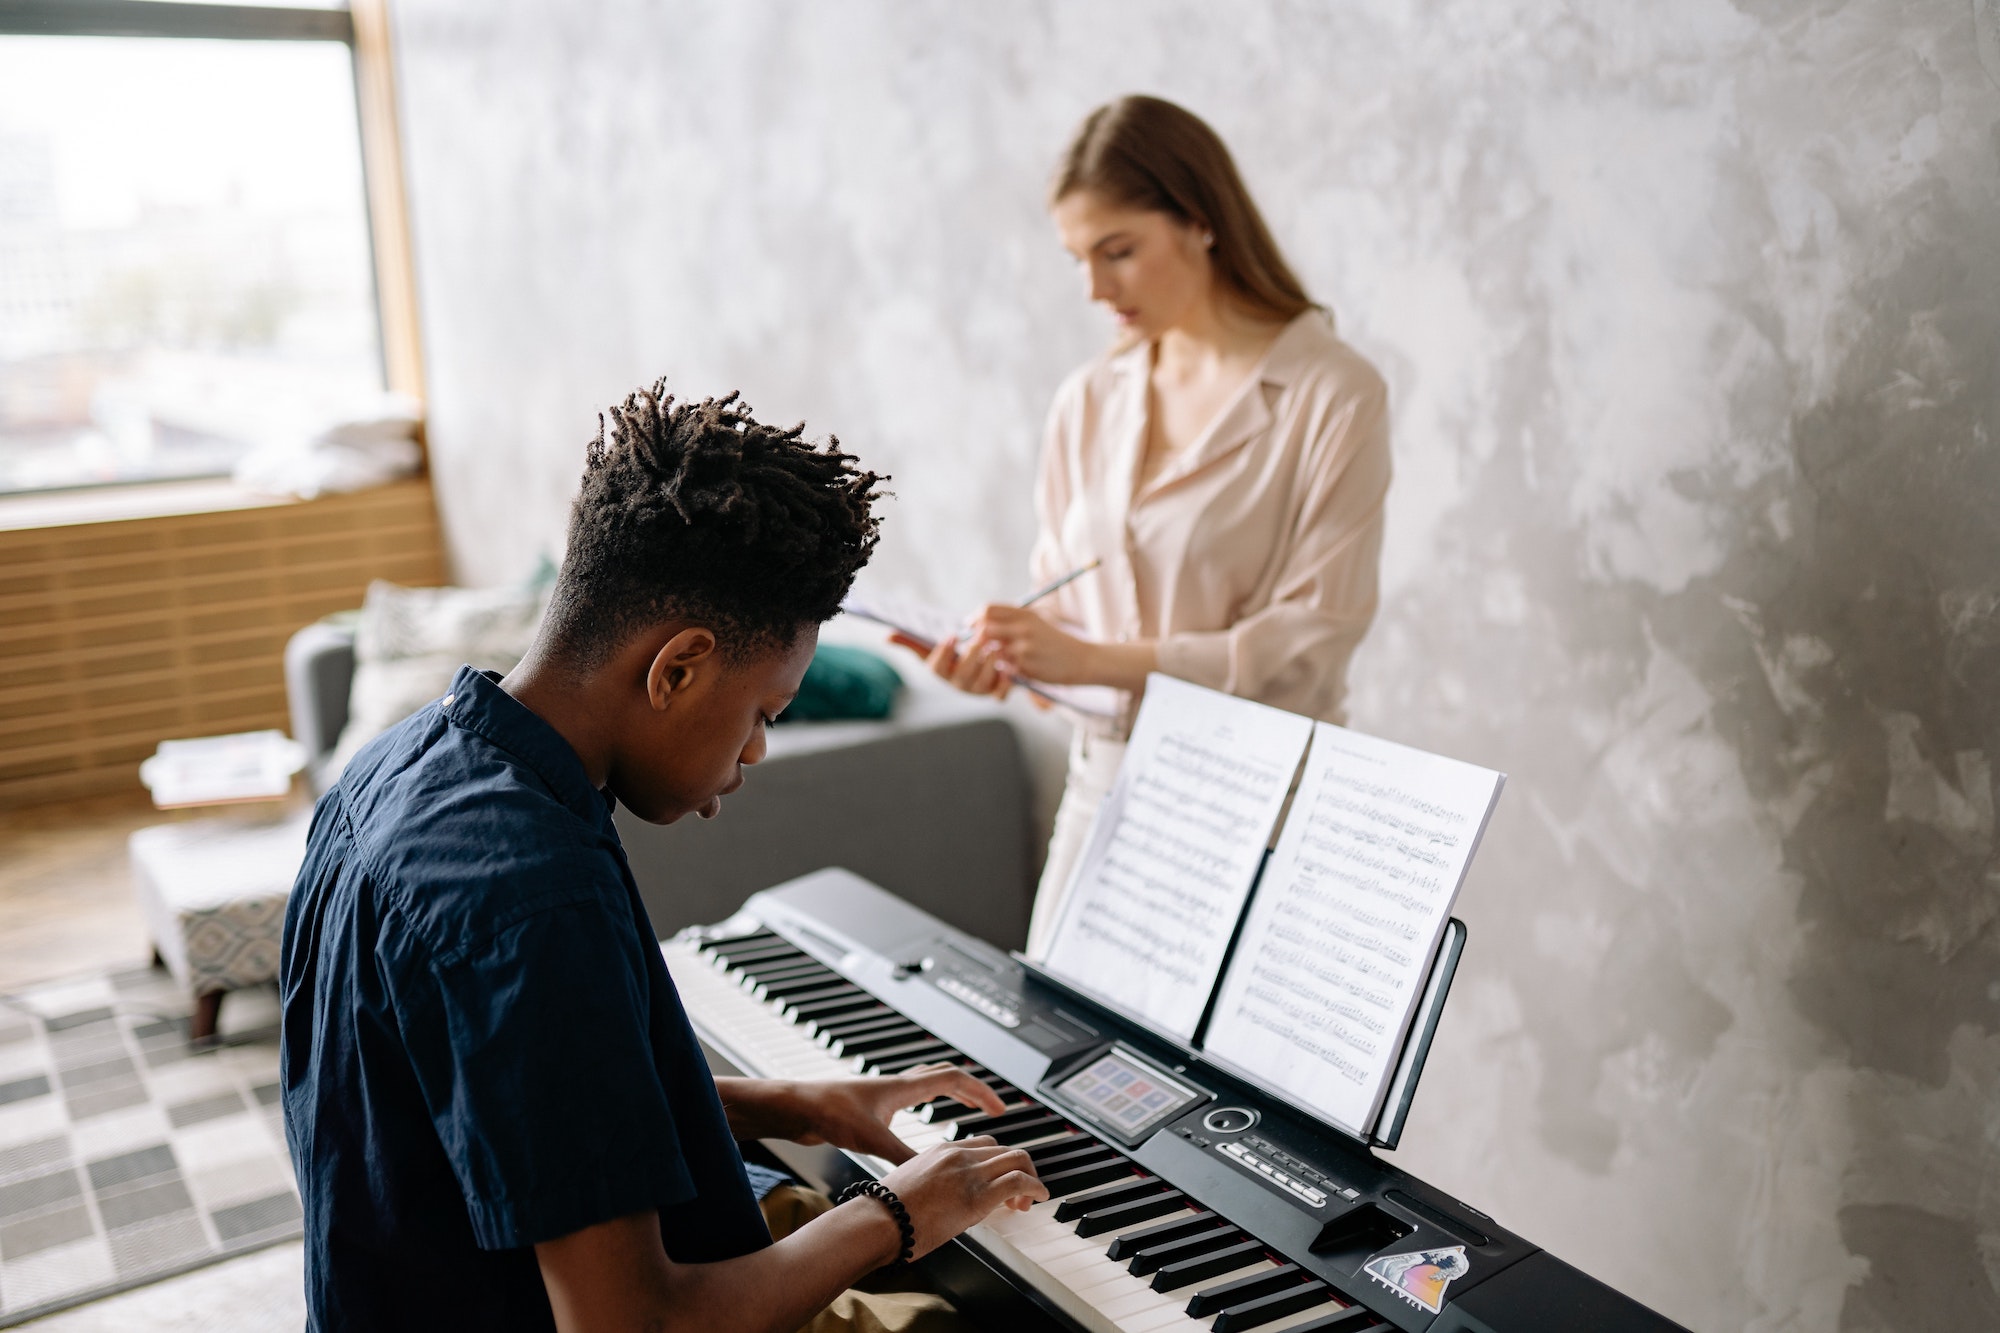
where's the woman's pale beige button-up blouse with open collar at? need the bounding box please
[1032,310,1390,735]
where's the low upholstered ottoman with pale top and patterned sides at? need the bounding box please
[130,811,312,1041]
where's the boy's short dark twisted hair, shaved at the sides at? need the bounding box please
[548,380,886,667]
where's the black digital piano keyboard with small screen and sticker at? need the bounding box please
[662,871,1678,1333]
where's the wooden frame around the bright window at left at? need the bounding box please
[0,0,426,512]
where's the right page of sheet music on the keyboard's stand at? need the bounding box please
[1204,723,1506,1137]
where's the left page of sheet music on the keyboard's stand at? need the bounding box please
[1044,675,1312,1041]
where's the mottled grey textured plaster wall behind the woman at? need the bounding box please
[386,0,2000,1333]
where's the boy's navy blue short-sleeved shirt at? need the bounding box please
[280,667,770,1331]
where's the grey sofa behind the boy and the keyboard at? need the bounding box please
[284,624,1036,949]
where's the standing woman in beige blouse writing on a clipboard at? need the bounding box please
[896,96,1390,959]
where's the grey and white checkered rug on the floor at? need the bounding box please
[0,956,300,1327]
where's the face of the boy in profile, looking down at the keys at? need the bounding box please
[610,624,820,825]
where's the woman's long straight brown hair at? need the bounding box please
[1048,96,1316,324]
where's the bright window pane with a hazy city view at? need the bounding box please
[0,36,382,490]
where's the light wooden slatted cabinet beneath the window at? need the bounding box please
[0,478,444,807]
